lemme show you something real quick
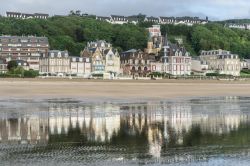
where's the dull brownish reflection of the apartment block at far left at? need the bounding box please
[0,116,49,144]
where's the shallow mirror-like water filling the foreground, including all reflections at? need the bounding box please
[0,97,250,166]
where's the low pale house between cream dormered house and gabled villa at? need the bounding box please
[70,57,91,77]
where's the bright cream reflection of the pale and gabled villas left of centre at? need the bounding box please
[49,104,120,142]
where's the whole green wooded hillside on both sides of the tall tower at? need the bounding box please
[0,15,250,58]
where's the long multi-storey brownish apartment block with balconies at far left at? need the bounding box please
[0,36,49,71]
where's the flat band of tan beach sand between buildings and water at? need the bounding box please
[0,79,250,100]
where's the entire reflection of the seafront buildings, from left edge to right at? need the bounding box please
[0,97,248,148]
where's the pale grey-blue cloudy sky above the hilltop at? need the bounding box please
[0,0,250,20]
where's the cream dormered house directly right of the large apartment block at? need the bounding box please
[39,50,70,76]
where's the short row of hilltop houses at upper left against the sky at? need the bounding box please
[6,12,49,19]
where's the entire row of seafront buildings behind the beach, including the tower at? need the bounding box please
[0,25,250,79]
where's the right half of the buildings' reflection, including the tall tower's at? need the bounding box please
[121,97,248,157]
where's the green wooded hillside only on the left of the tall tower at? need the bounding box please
[0,16,148,55]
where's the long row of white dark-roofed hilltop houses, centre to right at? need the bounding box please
[96,15,209,26]
